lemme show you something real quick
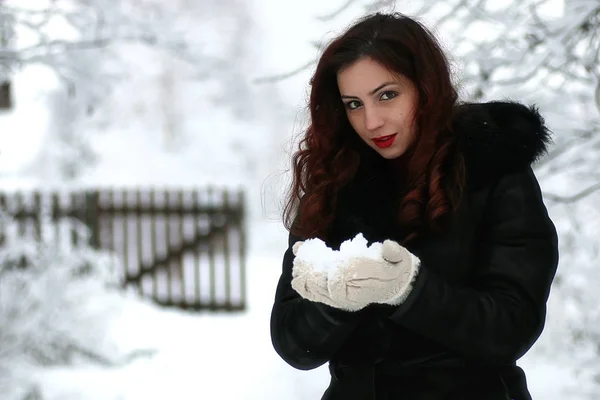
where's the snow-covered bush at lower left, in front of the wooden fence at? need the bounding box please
[0,207,157,399]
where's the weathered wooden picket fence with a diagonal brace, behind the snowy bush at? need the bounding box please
[0,188,246,311]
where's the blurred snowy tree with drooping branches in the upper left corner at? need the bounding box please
[0,0,220,180]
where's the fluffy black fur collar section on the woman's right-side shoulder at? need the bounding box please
[453,101,552,182]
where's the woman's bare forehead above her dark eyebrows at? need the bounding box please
[337,58,400,95]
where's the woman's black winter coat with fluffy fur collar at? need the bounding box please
[271,102,558,400]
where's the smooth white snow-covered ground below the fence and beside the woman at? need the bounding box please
[28,248,578,400]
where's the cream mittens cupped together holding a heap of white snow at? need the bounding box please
[291,234,420,311]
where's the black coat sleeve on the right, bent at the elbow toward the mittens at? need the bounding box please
[390,168,558,364]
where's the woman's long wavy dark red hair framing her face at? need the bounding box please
[283,13,465,242]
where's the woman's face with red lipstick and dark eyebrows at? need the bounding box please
[337,58,419,160]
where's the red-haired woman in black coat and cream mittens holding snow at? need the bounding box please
[271,10,558,400]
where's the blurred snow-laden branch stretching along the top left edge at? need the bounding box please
[0,0,210,82]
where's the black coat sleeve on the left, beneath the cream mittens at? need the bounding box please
[271,231,361,370]
